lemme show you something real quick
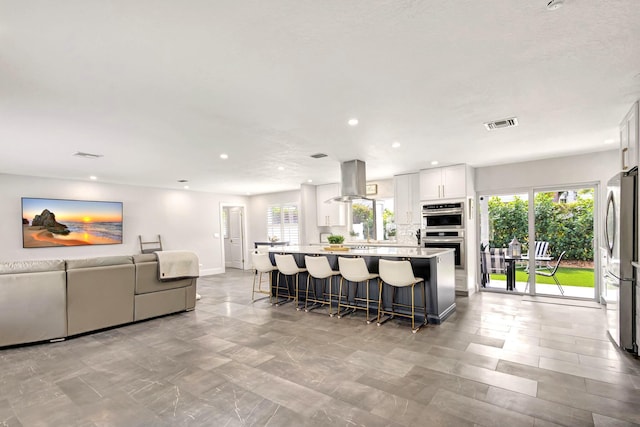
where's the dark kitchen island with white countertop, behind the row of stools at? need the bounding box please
[269,245,456,324]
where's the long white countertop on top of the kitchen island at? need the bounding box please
[269,244,454,258]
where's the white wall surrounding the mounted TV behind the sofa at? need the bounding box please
[0,174,246,275]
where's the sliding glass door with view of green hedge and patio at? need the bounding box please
[478,186,597,299]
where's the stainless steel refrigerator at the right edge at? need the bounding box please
[604,169,638,353]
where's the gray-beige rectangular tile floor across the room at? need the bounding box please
[0,270,640,427]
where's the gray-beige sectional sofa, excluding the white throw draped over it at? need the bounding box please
[0,254,197,347]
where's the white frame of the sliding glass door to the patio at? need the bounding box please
[475,181,602,302]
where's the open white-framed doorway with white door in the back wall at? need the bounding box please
[220,203,247,270]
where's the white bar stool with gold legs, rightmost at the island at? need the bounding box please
[378,259,427,334]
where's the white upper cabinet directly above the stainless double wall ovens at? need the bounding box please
[420,165,467,201]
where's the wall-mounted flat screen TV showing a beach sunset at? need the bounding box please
[22,197,122,248]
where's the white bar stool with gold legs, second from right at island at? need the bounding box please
[338,257,380,323]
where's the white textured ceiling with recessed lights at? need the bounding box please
[0,0,640,194]
